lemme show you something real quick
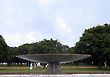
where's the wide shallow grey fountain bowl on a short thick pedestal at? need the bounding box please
[17,54,90,74]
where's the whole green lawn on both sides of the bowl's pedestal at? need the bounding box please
[0,66,110,74]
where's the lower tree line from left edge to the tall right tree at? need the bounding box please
[0,36,74,65]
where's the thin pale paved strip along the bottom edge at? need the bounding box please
[0,74,110,77]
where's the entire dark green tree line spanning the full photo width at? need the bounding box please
[0,24,110,68]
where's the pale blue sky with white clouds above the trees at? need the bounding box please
[0,0,110,46]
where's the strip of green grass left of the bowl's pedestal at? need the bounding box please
[0,66,46,74]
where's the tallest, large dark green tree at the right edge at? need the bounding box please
[75,24,110,68]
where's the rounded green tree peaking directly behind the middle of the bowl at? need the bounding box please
[31,39,63,54]
